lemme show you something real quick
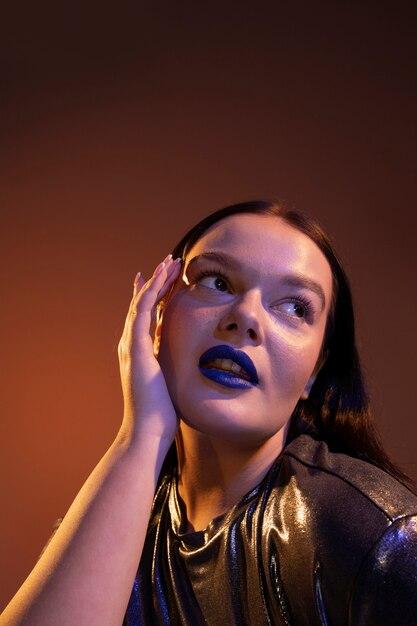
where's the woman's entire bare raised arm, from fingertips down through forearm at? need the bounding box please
[0,257,180,626]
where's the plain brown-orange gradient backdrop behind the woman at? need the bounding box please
[0,1,417,606]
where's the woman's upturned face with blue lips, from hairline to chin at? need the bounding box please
[156,214,332,445]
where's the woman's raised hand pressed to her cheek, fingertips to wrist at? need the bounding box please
[119,255,181,441]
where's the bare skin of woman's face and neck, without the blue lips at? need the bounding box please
[155,215,332,530]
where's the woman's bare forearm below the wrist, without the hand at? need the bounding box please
[0,426,171,626]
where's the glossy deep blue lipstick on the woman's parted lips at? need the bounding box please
[198,344,259,389]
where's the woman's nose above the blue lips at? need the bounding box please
[217,291,263,345]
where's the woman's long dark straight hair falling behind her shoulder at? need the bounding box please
[164,200,409,482]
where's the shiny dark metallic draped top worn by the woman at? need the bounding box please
[124,435,417,626]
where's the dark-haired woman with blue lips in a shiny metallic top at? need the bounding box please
[1,202,417,626]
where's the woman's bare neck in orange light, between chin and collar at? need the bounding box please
[177,422,286,532]
